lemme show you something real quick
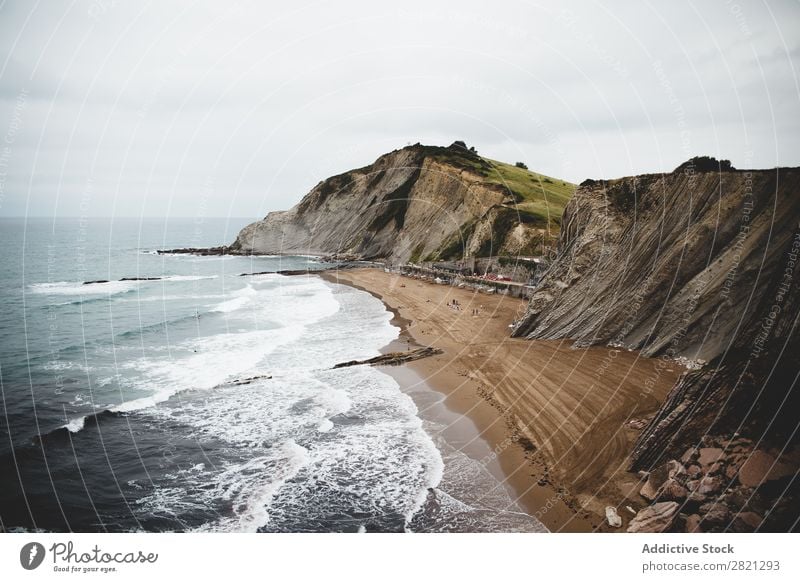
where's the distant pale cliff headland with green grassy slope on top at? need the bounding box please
[226,142,574,262]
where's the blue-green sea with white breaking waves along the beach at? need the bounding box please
[0,218,544,532]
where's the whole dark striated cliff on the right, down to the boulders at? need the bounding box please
[514,159,800,482]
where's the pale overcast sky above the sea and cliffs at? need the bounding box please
[0,0,800,219]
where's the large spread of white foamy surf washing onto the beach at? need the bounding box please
[101,275,443,531]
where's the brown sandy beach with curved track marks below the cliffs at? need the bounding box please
[322,269,682,532]
